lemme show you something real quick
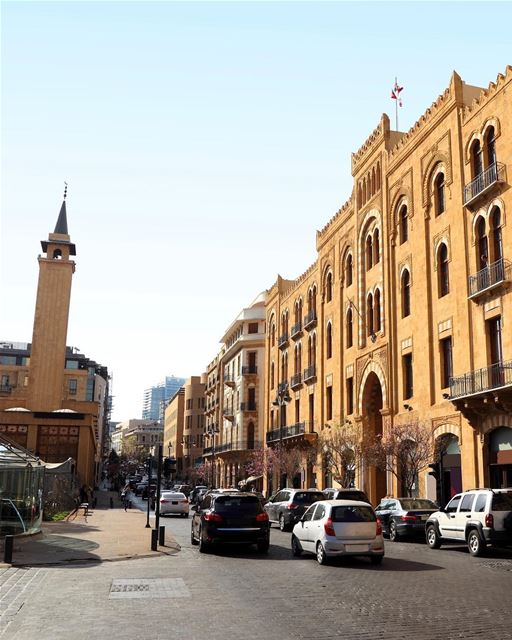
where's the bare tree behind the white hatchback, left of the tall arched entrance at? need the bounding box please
[318,421,365,487]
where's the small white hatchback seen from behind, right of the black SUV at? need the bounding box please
[292,500,384,564]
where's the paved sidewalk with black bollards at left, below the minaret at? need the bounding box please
[0,491,180,568]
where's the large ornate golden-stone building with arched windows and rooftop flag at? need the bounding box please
[265,67,512,503]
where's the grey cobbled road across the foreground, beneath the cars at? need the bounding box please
[4,496,512,640]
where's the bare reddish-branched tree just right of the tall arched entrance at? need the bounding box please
[365,422,435,496]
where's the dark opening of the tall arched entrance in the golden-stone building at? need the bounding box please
[361,371,387,504]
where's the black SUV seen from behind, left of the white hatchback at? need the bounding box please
[190,492,270,553]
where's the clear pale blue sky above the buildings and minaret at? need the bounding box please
[0,1,512,420]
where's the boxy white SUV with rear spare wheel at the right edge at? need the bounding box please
[425,488,512,556]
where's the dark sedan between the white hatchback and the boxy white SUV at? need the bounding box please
[375,498,439,542]
